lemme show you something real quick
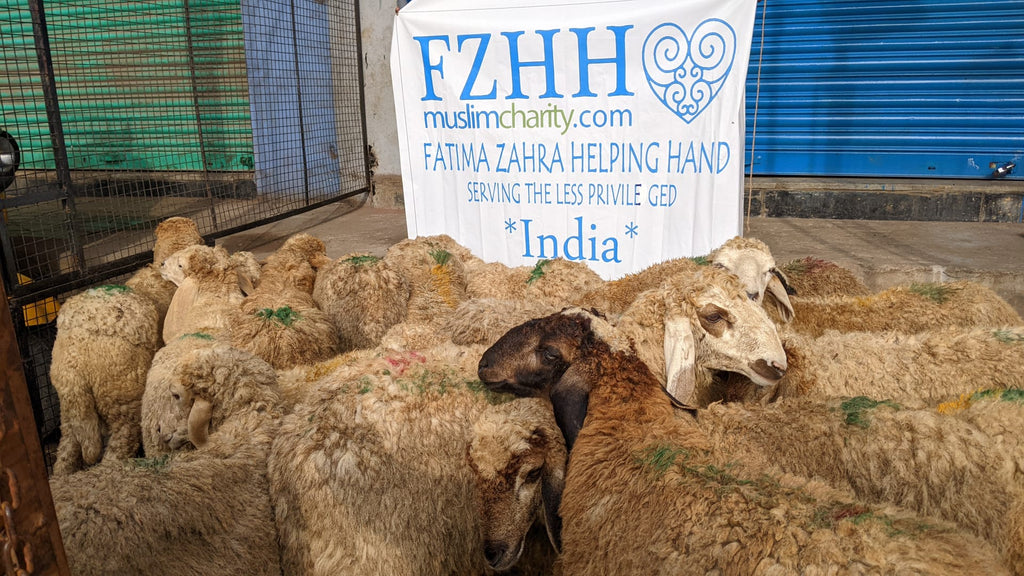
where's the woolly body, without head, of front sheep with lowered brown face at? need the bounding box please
[269,358,512,575]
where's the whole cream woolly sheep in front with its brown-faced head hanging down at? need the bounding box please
[269,350,565,575]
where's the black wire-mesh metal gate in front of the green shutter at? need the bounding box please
[0,0,370,463]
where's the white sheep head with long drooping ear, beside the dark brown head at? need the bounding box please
[659,268,786,403]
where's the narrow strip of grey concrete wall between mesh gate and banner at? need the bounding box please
[359,0,404,207]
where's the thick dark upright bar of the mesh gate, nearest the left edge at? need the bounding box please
[27,0,85,276]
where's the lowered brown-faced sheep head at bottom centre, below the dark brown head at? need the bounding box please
[467,399,567,571]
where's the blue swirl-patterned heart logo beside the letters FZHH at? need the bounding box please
[643,18,736,124]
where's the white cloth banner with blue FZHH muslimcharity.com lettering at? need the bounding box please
[391,0,756,280]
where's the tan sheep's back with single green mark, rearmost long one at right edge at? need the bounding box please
[787,282,1024,336]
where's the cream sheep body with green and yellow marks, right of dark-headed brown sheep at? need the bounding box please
[697,389,1024,574]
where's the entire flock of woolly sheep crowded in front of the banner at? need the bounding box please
[44,217,1024,576]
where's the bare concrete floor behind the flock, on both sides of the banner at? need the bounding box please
[217,199,1024,315]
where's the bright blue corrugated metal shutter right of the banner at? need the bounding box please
[745,0,1024,178]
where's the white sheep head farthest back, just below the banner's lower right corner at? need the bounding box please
[711,236,794,322]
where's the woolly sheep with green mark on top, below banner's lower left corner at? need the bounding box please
[313,254,411,351]
